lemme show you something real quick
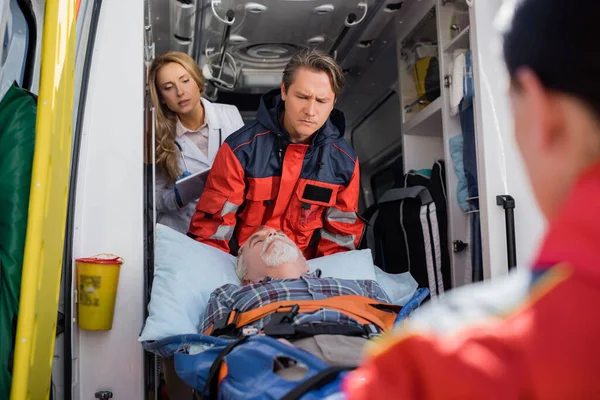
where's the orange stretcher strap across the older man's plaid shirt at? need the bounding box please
[204,295,402,335]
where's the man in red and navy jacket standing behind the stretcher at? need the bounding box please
[188,50,364,259]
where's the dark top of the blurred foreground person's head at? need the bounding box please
[499,0,600,119]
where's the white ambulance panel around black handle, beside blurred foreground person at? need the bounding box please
[471,1,544,279]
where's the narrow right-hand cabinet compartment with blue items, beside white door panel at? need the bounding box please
[437,0,484,286]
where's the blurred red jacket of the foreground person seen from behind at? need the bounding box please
[344,163,600,400]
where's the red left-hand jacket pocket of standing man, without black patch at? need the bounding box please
[241,177,279,227]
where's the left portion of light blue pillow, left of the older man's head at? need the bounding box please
[139,224,240,341]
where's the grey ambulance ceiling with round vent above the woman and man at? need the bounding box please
[148,0,406,87]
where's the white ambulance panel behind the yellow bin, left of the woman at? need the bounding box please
[72,0,145,400]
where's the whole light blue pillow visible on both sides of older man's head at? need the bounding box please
[139,224,417,342]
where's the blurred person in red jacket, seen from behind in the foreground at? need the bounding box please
[344,0,600,400]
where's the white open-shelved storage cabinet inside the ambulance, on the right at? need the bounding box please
[397,0,481,286]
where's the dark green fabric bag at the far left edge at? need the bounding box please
[0,84,37,399]
